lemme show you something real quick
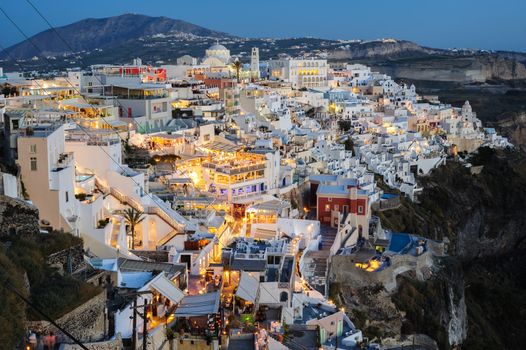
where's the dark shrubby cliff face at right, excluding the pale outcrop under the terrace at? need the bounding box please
[379,149,526,349]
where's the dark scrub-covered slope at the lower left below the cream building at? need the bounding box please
[0,197,100,349]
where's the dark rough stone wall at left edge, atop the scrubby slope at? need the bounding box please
[0,196,40,236]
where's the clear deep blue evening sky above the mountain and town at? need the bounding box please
[0,0,526,52]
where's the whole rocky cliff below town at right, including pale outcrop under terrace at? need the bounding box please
[330,148,526,349]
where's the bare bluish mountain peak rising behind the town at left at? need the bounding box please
[0,14,231,59]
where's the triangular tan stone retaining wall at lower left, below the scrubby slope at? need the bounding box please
[28,291,108,343]
